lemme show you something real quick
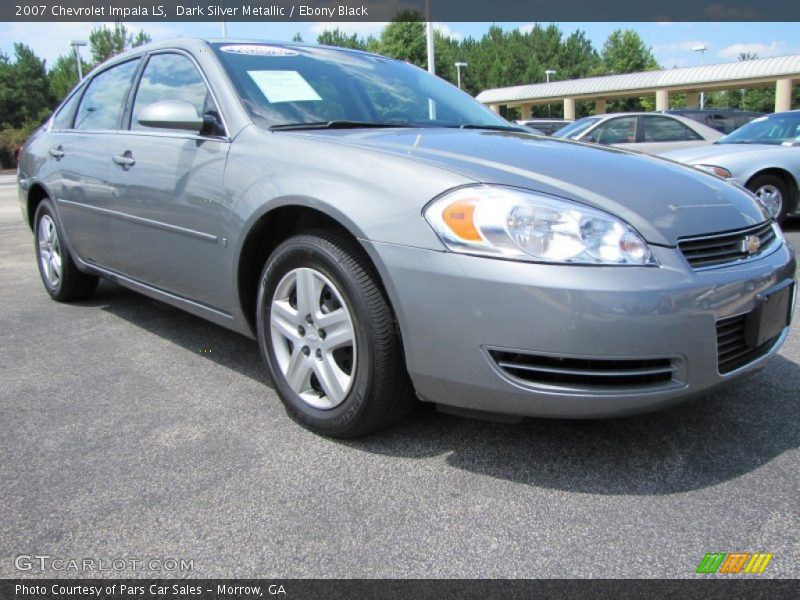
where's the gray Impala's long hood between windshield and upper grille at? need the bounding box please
[297,128,766,246]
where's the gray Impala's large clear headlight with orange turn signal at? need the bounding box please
[424,185,656,265]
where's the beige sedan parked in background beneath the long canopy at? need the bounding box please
[553,112,723,154]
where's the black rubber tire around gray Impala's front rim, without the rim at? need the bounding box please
[257,230,414,438]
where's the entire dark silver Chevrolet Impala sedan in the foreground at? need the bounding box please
[19,39,795,437]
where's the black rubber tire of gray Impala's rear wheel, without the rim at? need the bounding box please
[33,198,97,302]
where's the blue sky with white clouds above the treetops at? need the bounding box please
[0,22,800,73]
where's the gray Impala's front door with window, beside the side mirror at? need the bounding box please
[110,51,232,311]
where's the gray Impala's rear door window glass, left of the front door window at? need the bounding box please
[75,59,139,130]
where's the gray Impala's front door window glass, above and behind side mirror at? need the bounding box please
[131,54,216,130]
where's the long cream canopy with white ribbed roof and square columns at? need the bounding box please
[477,54,800,119]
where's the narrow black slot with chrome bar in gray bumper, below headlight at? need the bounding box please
[489,350,675,387]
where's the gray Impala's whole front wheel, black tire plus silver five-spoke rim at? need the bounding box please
[257,231,413,438]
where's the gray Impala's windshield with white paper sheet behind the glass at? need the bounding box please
[212,43,518,130]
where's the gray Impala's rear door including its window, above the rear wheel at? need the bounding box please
[48,59,140,266]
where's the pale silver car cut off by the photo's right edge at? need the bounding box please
[662,110,800,222]
